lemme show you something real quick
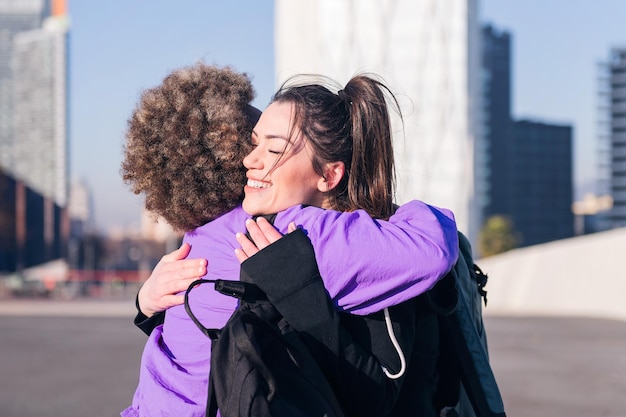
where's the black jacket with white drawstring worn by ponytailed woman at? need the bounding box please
[236,230,439,417]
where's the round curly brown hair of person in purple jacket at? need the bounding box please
[122,63,260,231]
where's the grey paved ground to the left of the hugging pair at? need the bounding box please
[0,301,146,417]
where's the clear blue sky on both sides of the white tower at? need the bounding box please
[69,0,626,232]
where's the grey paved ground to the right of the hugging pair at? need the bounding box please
[486,317,626,417]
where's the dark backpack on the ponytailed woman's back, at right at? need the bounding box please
[426,233,506,417]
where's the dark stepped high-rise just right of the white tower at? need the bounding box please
[478,25,574,246]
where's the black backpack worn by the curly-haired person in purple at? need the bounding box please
[185,279,343,417]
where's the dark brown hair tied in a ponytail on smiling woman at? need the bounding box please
[272,75,400,218]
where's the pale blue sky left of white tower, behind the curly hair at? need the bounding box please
[69,0,274,231]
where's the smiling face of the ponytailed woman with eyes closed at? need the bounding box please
[243,102,329,215]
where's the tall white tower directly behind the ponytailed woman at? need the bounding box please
[275,0,481,240]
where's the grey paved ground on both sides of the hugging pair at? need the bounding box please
[0,300,626,417]
